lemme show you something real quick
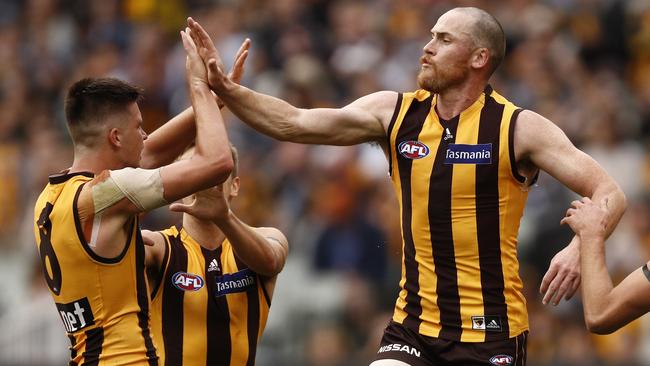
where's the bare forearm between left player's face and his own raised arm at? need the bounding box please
[140,107,196,169]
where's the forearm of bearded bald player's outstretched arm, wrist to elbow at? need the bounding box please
[218,83,300,142]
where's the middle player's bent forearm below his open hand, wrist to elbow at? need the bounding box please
[215,211,284,277]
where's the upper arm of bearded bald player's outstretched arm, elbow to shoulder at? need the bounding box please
[288,91,397,145]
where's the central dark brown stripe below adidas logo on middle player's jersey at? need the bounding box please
[206,246,232,365]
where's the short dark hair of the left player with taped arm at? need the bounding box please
[65,78,143,147]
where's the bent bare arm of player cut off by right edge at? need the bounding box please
[562,198,650,334]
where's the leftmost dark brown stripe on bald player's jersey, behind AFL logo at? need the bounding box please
[394,96,433,332]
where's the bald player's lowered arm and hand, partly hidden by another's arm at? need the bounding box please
[514,111,627,305]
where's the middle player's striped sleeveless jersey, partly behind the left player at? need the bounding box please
[152,227,271,366]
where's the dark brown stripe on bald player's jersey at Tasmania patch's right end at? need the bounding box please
[476,96,509,341]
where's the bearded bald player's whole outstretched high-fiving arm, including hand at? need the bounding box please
[188,19,397,145]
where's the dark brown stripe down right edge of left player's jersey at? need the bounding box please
[131,227,158,366]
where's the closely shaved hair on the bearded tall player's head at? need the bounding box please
[457,7,506,75]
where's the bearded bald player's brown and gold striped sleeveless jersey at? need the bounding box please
[387,86,528,342]
